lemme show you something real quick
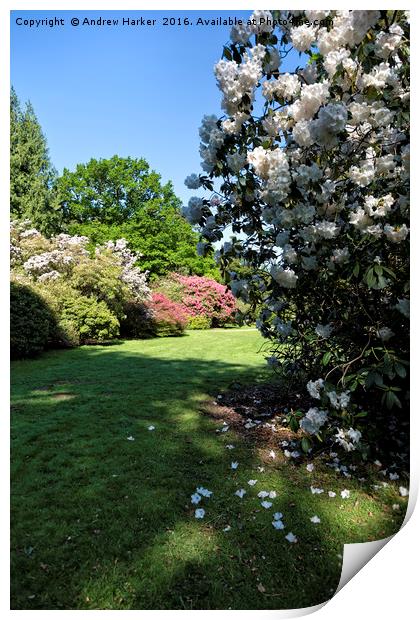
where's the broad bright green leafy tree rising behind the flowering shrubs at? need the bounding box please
[57,155,220,279]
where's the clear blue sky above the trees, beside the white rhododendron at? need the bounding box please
[11,11,298,203]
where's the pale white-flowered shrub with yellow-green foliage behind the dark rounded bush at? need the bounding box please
[10,221,150,345]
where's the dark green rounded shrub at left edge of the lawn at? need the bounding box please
[10,282,56,358]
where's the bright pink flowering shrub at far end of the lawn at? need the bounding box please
[158,273,238,327]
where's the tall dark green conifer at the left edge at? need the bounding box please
[10,88,60,234]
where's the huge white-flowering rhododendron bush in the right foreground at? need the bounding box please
[184,11,410,453]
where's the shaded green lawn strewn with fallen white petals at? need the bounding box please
[11,330,404,609]
